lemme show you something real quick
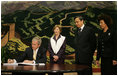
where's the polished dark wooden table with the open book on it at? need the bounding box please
[1,64,89,74]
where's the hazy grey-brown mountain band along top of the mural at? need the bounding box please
[1,1,117,14]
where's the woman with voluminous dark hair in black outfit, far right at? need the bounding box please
[96,14,117,75]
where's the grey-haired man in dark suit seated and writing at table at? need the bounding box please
[8,36,46,63]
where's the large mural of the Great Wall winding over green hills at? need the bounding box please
[1,1,117,70]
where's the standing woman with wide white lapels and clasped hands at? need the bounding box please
[48,25,66,64]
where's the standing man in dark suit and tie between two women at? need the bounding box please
[74,16,96,75]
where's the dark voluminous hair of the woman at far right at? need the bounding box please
[98,14,113,28]
